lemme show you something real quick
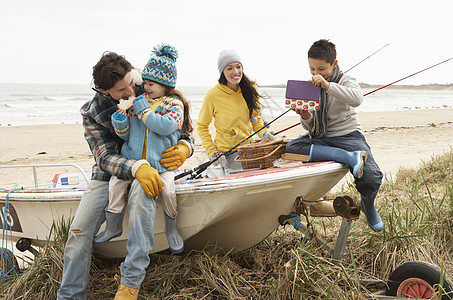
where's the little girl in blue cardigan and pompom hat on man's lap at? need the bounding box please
[94,44,193,253]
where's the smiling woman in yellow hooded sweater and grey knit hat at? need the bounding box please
[197,49,273,170]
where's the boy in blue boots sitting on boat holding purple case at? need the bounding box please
[286,40,383,231]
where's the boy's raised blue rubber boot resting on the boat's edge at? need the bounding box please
[310,145,368,178]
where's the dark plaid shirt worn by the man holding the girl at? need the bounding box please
[80,85,193,181]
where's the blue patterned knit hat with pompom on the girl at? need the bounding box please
[142,44,178,87]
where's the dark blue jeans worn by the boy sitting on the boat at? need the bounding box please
[286,131,383,200]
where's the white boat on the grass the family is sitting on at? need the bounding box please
[0,162,349,258]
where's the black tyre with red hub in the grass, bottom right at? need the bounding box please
[386,261,453,300]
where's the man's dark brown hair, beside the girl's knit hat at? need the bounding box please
[93,51,132,91]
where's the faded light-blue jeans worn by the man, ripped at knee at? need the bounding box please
[57,179,156,299]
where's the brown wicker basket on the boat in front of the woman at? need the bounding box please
[236,140,287,169]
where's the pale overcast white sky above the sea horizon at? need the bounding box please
[0,0,453,86]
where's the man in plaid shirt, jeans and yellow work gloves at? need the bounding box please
[57,52,193,299]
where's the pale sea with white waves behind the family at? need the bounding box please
[0,83,453,126]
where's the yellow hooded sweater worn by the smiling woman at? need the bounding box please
[196,83,263,155]
